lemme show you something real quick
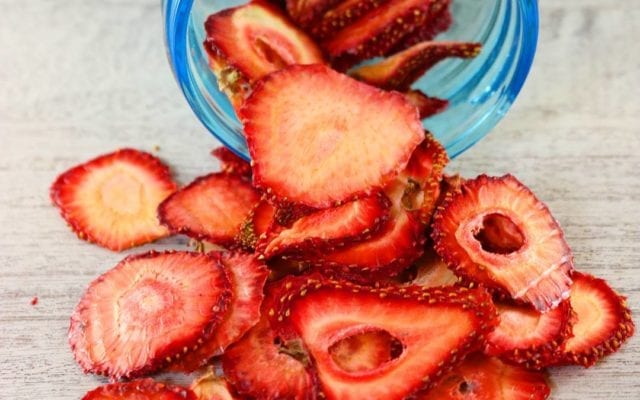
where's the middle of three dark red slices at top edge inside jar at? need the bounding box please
[308,0,389,40]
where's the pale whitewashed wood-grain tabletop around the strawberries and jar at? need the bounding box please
[0,0,640,400]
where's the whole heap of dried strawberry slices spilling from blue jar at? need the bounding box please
[50,0,634,400]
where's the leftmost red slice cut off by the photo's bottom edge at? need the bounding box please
[82,378,198,400]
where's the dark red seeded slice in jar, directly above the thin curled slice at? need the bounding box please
[320,0,431,70]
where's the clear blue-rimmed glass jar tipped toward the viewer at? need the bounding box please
[162,0,538,159]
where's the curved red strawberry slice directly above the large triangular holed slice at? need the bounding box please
[306,181,425,282]
